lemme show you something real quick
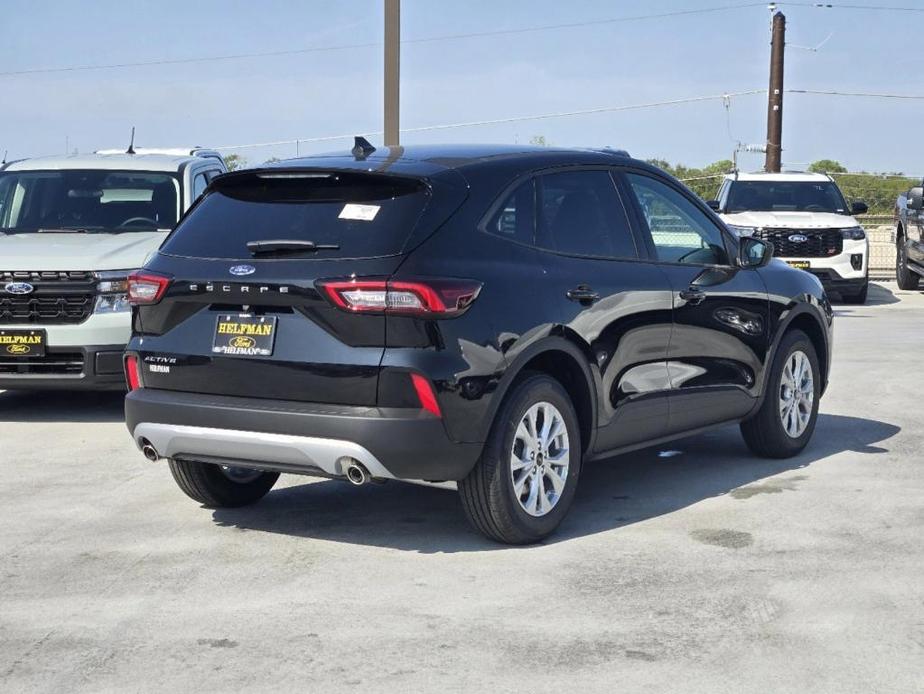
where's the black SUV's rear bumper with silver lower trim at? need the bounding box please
[125,388,481,481]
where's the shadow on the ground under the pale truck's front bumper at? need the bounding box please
[0,390,125,422]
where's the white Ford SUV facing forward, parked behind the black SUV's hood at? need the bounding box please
[709,173,869,304]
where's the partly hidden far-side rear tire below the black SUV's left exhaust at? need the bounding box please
[169,460,279,508]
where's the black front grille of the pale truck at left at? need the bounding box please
[0,271,96,325]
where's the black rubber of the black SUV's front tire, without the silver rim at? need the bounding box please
[741,330,822,458]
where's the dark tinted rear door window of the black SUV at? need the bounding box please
[538,171,638,258]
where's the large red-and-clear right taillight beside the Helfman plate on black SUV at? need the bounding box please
[317,278,481,318]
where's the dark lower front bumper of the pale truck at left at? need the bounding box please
[0,346,125,390]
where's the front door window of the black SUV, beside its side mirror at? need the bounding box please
[626,173,728,265]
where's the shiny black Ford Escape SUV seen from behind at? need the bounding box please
[126,141,832,543]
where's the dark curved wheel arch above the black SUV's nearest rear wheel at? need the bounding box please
[482,331,597,452]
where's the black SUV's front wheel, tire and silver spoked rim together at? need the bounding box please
[741,330,821,458]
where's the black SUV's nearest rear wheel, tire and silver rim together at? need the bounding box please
[459,375,582,545]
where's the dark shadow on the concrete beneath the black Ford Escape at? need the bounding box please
[213,414,900,553]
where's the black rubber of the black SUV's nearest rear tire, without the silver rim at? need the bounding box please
[459,374,582,545]
